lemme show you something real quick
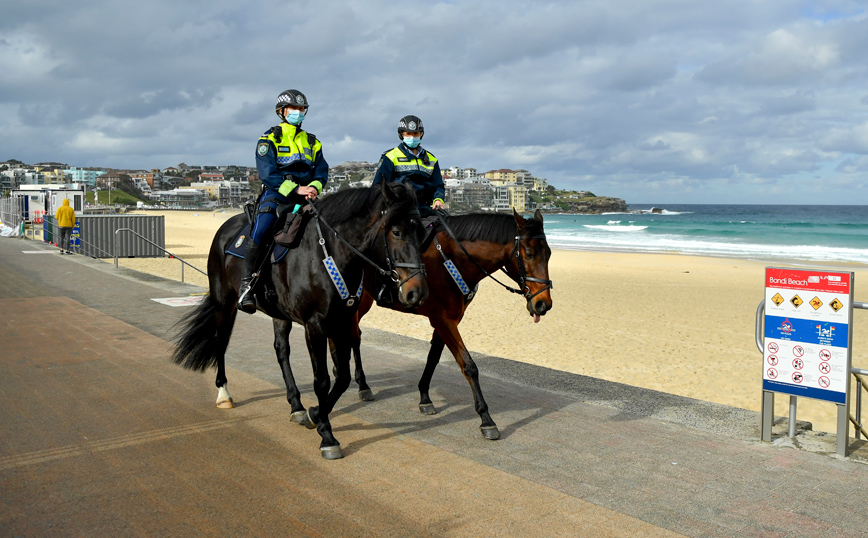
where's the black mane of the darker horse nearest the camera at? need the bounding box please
[317,182,416,243]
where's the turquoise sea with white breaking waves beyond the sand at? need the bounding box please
[545,203,868,266]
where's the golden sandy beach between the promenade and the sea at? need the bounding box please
[117,207,868,432]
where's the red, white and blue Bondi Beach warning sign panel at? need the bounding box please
[763,267,853,404]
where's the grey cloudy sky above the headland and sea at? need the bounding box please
[0,0,868,204]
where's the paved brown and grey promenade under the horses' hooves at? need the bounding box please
[0,238,868,538]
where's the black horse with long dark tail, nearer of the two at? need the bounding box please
[172,183,428,459]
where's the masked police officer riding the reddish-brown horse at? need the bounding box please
[372,116,446,217]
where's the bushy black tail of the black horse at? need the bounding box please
[172,294,225,372]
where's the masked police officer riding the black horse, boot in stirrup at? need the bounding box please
[238,90,329,314]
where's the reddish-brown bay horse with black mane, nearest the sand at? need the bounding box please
[353,210,552,440]
